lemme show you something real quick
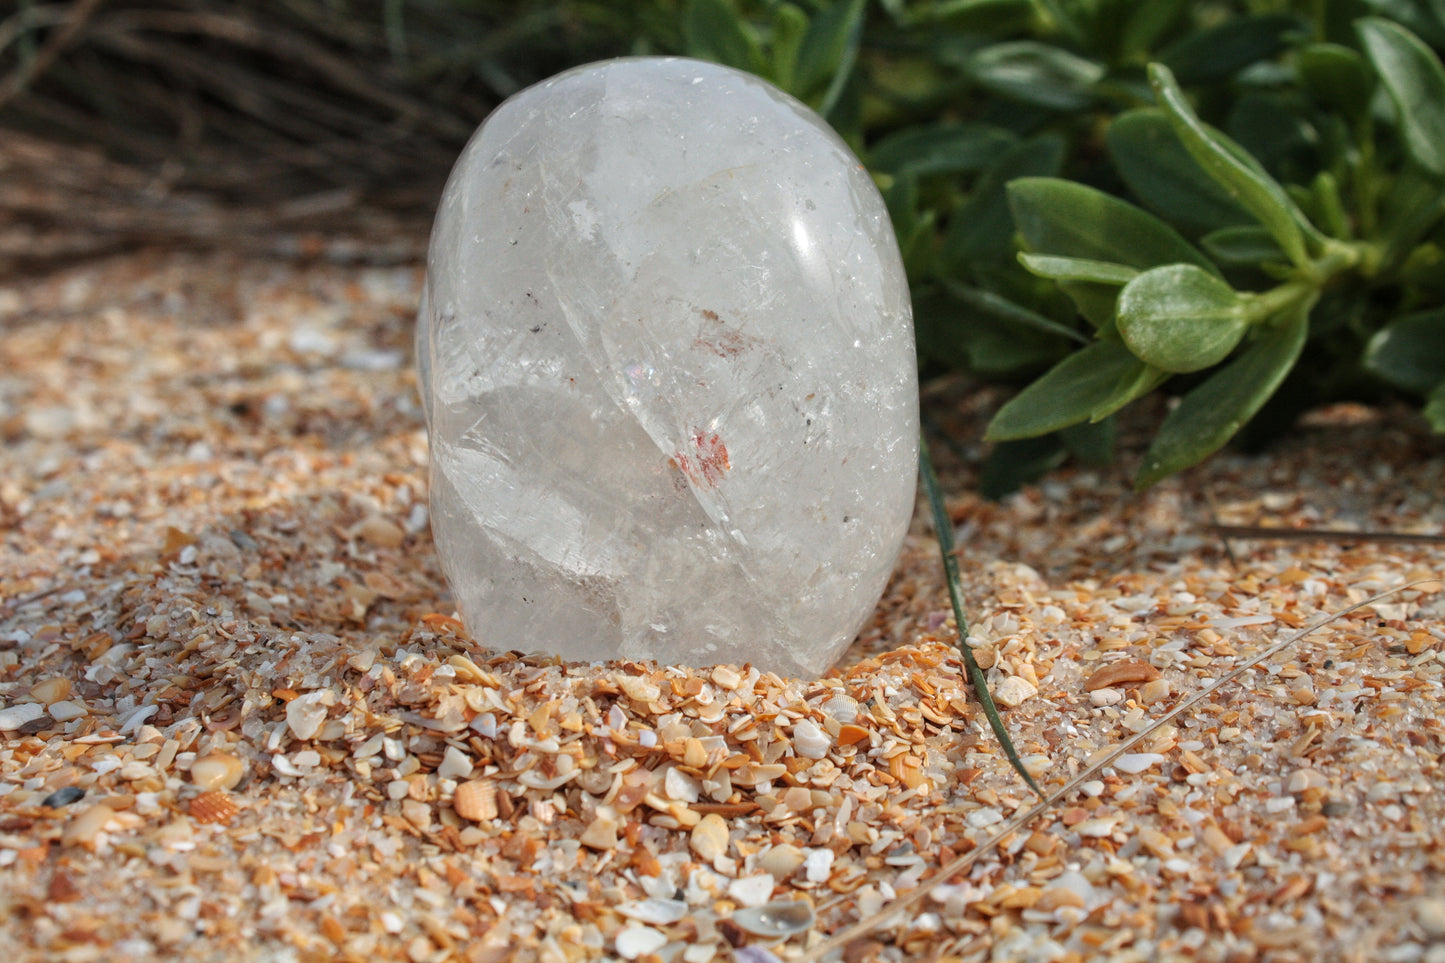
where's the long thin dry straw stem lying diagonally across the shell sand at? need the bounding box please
[799,578,1441,960]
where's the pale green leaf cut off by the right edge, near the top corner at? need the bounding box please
[1355,17,1445,174]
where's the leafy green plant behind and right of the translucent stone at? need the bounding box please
[661,0,1445,496]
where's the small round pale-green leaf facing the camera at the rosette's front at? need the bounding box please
[1116,265,1248,373]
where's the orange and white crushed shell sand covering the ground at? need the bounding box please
[0,253,1445,963]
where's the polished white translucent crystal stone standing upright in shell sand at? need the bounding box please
[418,58,918,674]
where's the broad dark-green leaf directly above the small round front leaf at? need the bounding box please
[1009,178,1217,273]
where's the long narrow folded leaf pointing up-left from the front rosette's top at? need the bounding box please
[1149,64,1324,268]
